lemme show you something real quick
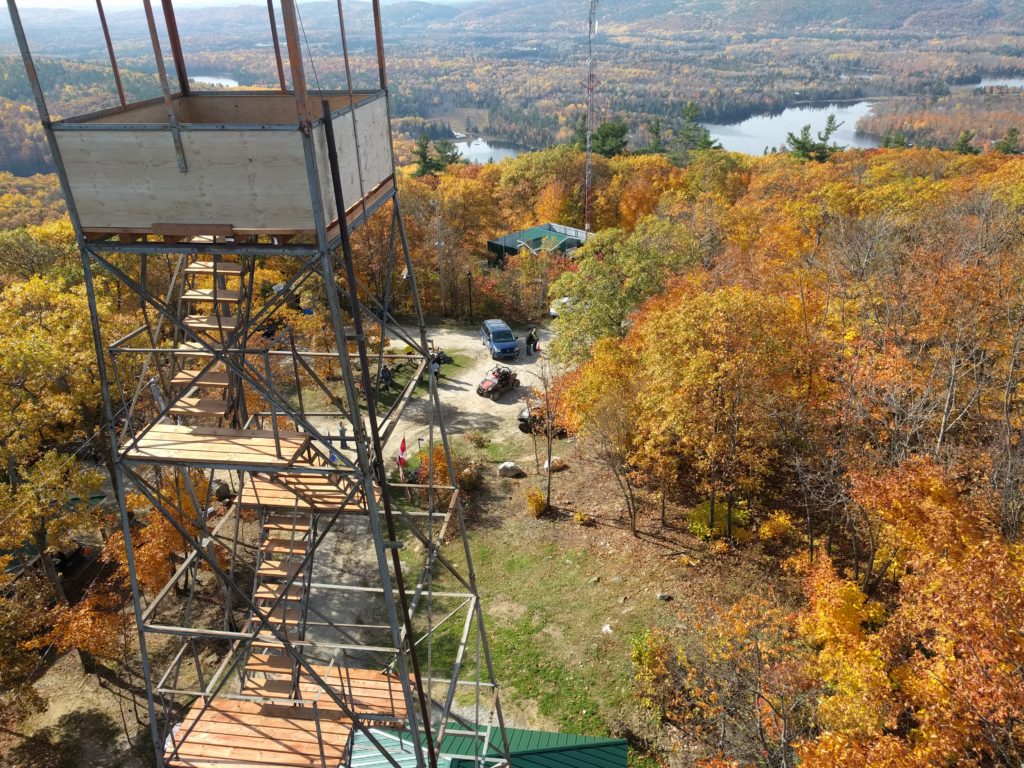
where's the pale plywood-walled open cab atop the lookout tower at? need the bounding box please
[53,91,394,240]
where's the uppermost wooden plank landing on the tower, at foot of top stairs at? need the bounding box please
[124,424,309,468]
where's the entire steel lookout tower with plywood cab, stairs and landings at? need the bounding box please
[7,0,509,768]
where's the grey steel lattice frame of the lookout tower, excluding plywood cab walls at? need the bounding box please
[7,0,509,768]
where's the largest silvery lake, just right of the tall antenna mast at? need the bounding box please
[705,101,880,155]
